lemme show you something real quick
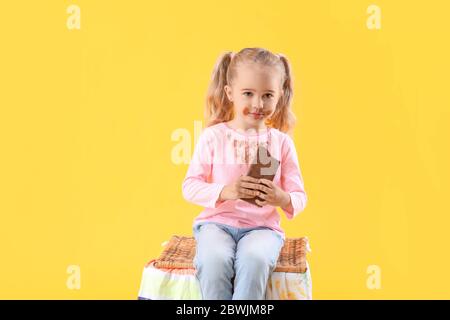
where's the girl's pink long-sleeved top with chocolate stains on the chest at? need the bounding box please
[182,122,307,239]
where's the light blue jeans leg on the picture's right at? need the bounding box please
[232,229,284,300]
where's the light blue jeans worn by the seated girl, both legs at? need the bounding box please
[192,221,284,300]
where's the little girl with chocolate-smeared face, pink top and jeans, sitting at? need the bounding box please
[182,48,307,300]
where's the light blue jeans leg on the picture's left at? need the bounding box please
[193,223,236,300]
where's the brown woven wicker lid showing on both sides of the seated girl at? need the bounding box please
[154,236,308,273]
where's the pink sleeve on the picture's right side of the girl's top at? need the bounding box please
[281,136,307,219]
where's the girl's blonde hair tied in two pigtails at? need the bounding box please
[205,48,296,134]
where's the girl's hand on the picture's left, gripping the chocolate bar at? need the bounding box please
[219,176,266,201]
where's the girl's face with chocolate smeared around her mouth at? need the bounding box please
[224,63,283,129]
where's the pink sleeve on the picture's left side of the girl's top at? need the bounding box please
[182,130,225,208]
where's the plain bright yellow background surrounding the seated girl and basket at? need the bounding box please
[0,0,450,299]
